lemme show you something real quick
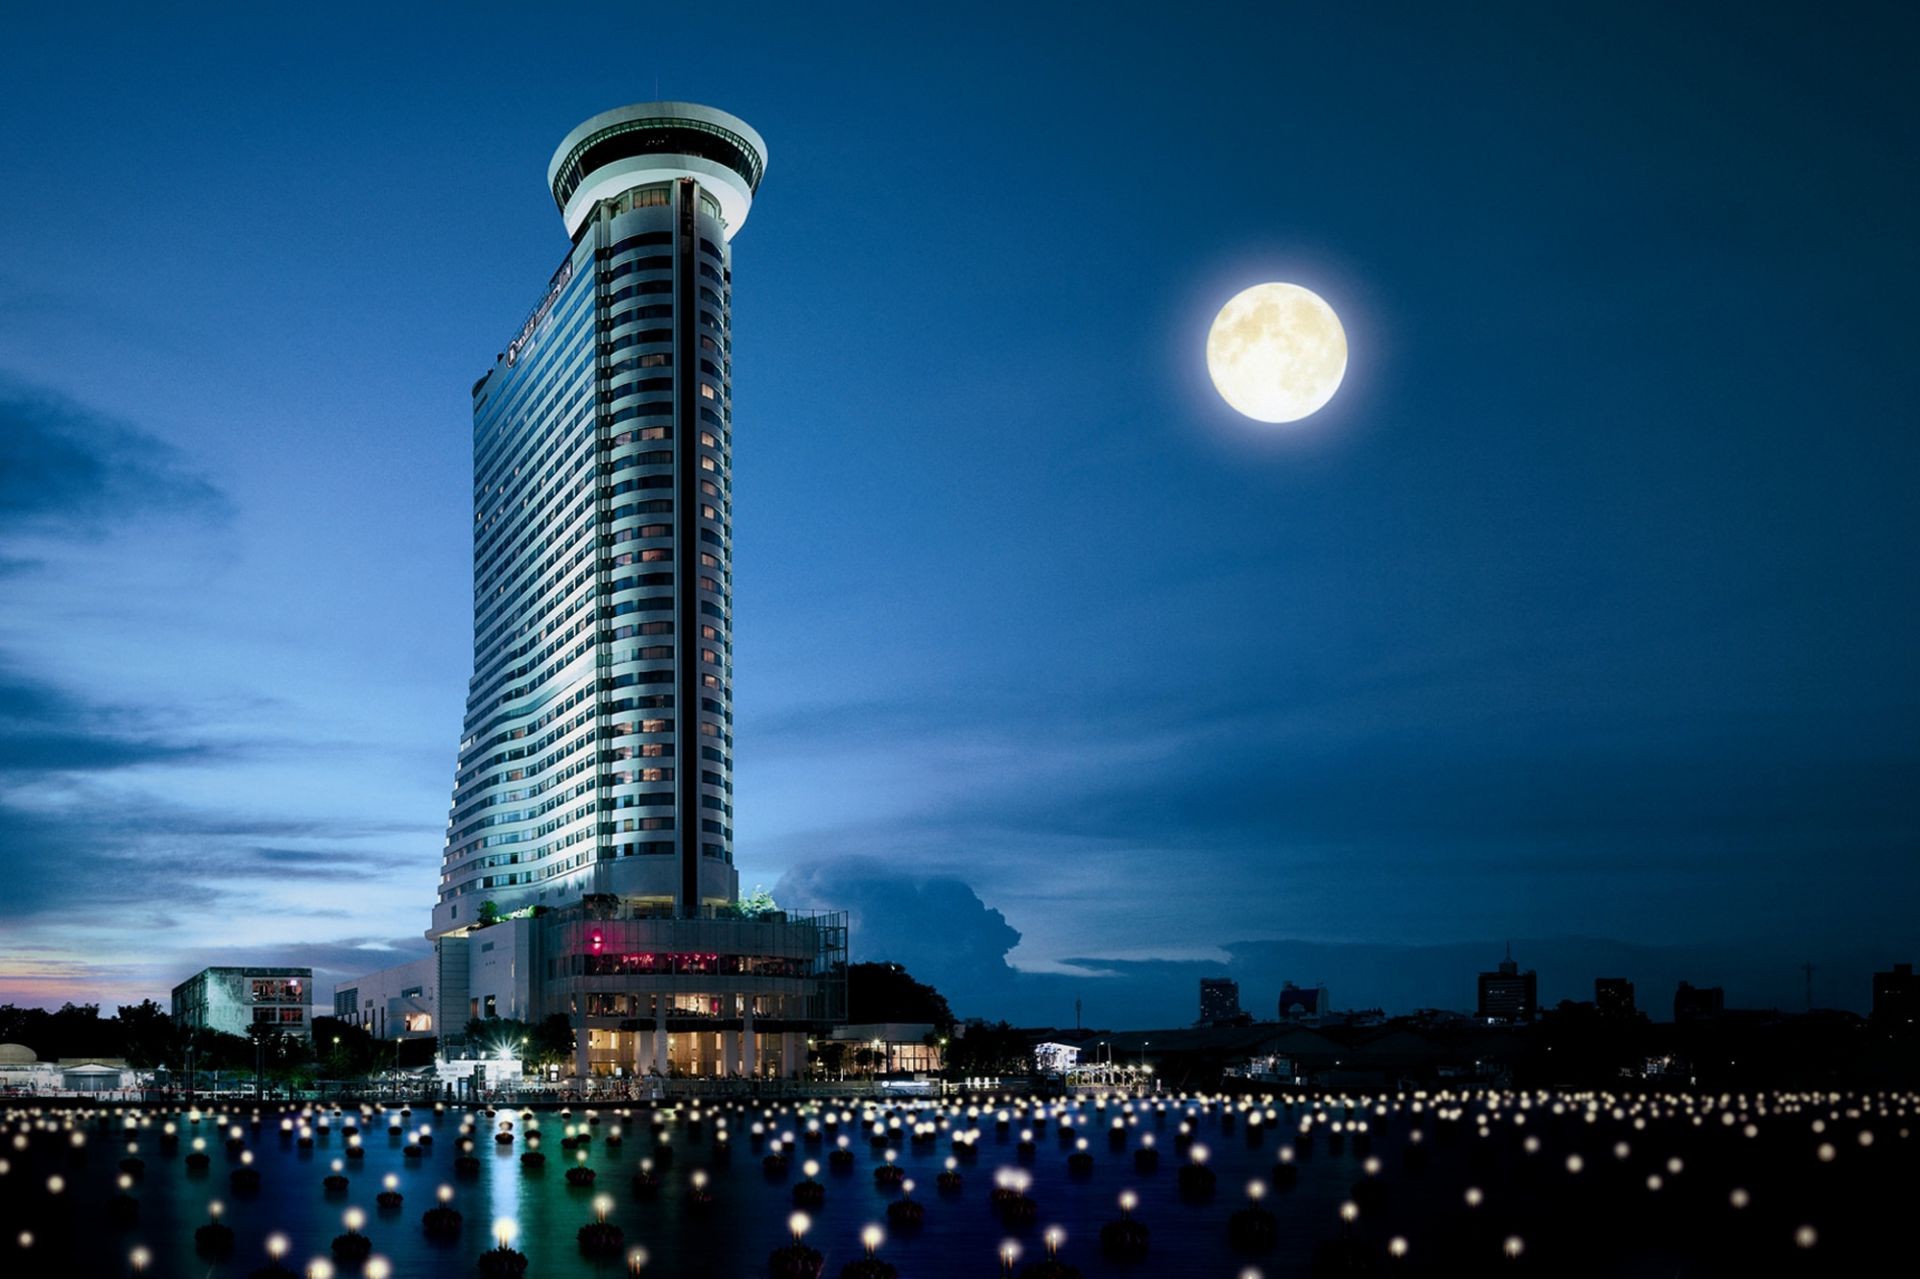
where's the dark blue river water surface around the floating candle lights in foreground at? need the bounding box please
[0,1102,1914,1279]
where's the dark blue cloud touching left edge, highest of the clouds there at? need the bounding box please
[0,386,227,533]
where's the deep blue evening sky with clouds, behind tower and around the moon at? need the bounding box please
[0,4,1920,1026]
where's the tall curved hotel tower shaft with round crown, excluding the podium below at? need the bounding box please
[434,102,766,931]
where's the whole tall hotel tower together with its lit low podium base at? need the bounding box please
[416,102,845,1074]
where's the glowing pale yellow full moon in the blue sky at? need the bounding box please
[1206,284,1346,422]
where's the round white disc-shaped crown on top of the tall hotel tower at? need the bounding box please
[547,102,766,240]
